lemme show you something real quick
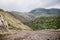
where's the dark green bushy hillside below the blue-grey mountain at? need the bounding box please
[28,14,60,30]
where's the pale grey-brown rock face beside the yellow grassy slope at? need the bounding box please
[0,14,8,32]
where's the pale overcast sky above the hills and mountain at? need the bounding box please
[0,0,60,12]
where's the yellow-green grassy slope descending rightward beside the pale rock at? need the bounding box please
[0,11,31,30]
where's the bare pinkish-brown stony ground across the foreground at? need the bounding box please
[0,30,60,40]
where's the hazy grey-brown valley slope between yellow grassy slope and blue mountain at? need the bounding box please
[10,11,34,24]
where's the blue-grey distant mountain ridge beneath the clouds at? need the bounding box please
[29,8,60,15]
